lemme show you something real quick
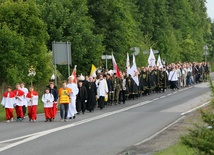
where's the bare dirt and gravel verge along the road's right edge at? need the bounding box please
[118,107,207,155]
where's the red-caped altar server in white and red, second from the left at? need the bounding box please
[13,84,25,122]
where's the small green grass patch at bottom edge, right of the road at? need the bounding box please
[153,143,196,155]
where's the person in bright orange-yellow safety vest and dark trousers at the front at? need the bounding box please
[59,81,72,122]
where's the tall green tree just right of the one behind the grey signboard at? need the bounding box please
[88,0,142,69]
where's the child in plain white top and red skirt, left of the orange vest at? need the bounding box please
[42,87,54,122]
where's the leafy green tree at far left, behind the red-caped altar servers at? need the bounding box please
[0,0,52,83]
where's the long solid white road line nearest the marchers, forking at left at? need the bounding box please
[0,101,151,152]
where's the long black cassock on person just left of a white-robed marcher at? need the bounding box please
[86,82,97,112]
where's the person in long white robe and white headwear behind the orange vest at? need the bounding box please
[67,75,79,119]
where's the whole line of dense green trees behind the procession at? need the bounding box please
[0,0,214,84]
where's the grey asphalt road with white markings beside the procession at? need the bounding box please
[0,83,210,155]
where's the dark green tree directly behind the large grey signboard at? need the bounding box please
[37,0,104,77]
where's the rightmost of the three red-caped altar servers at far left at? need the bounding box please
[26,86,39,122]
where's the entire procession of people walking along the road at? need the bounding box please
[1,62,209,122]
